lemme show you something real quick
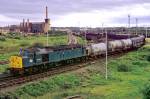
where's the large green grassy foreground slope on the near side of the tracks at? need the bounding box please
[1,38,150,99]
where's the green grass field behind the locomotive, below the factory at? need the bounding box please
[0,35,84,72]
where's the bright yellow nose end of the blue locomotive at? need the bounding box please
[9,56,23,68]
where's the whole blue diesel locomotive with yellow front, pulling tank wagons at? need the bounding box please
[10,45,86,74]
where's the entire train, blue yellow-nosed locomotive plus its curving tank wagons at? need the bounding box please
[9,36,145,75]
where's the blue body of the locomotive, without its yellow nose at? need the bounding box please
[15,45,86,68]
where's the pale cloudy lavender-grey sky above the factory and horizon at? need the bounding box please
[0,0,150,27]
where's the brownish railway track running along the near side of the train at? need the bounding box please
[0,53,124,91]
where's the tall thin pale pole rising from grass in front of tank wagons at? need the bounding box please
[105,25,108,80]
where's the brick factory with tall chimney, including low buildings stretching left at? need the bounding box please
[1,6,50,34]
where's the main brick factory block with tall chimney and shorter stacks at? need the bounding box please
[20,7,50,33]
